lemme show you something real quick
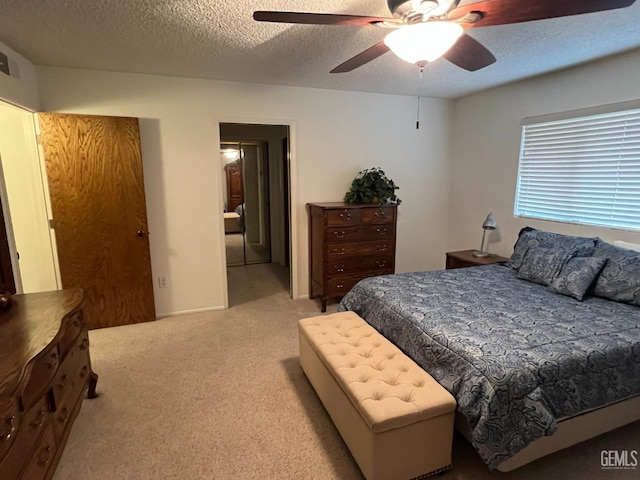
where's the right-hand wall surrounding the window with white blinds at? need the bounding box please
[447,50,640,256]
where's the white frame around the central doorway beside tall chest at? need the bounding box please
[214,117,300,309]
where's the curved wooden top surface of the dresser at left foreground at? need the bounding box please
[0,288,84,395]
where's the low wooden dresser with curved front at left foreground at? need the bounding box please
[0,289,98,480]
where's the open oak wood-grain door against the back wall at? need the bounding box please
[38,113,155,328]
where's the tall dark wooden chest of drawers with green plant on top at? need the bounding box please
[307,202,397,312]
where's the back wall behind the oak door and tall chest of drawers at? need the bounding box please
[37,68,451,315]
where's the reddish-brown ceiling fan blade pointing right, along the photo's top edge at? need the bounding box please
[447,0,635,27]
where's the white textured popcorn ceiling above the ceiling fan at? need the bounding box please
[0,0,640,98]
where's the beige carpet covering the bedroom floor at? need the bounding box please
[54,264,640,480]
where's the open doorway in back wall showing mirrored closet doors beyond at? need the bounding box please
[220,123,291,305]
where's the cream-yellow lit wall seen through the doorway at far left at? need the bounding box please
[0,103,58,293]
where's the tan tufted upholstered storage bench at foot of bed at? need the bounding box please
[298,312,456,480]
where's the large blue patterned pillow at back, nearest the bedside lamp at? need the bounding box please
[506,227,598,270]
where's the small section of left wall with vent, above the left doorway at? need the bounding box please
[0,42,40,110]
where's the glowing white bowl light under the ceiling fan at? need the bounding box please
[384,22,464,65]
